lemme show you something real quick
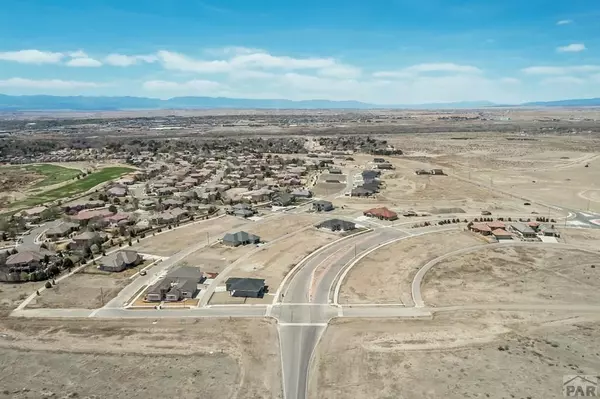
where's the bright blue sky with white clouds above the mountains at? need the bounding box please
[0,0,600,104]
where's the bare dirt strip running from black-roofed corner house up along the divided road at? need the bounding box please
[221,228,339,292]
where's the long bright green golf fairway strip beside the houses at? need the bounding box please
[11,167,134,212]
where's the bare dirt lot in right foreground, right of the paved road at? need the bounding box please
[309,312,600,399]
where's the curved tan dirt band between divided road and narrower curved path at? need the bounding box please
[339,231,485,305]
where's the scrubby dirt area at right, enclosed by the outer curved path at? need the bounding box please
[422,247,600,306]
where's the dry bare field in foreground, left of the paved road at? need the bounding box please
[0,319,281,399]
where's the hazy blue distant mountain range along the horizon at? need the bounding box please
[0,94,600,112]
